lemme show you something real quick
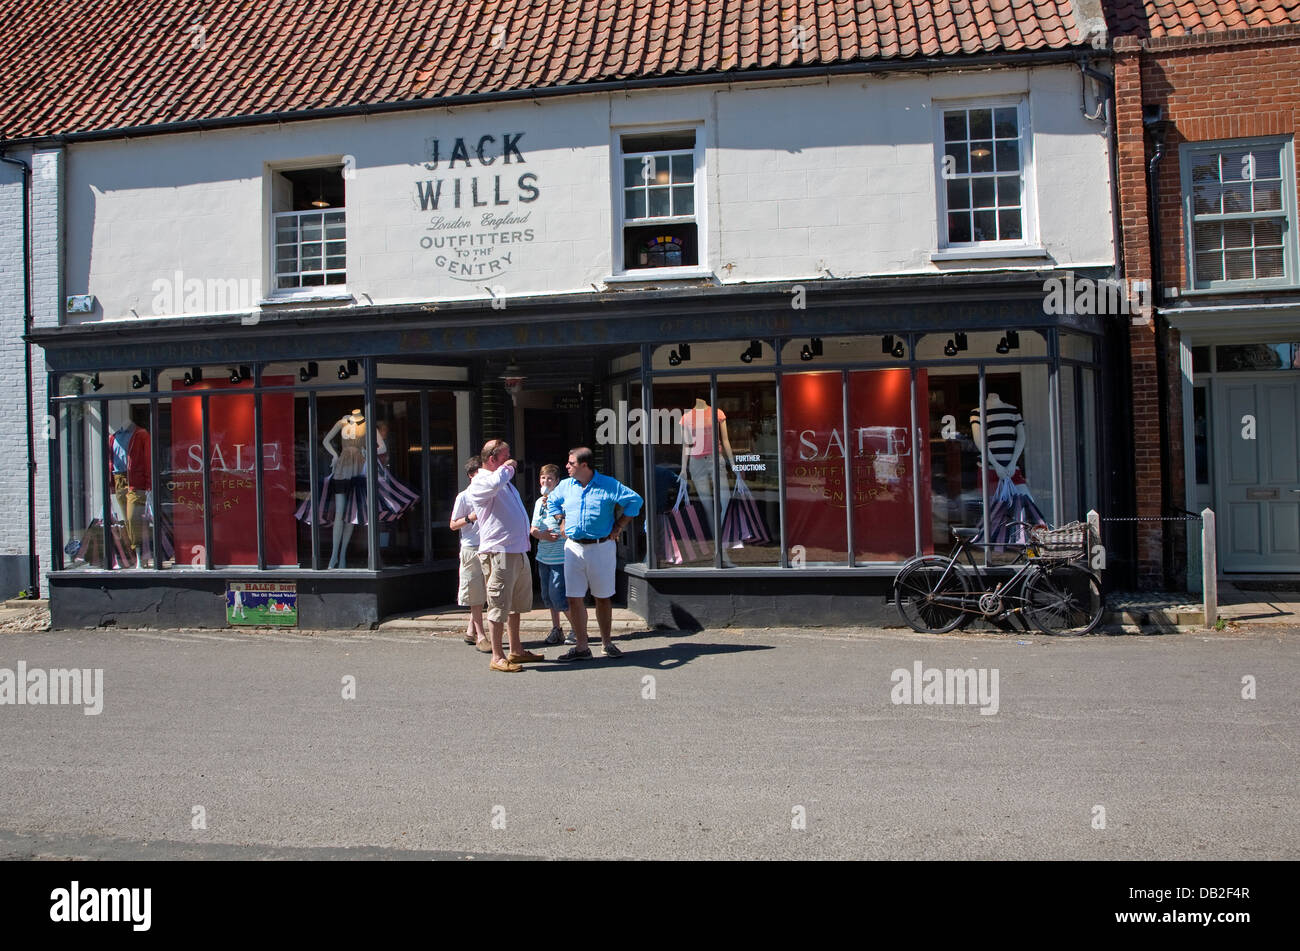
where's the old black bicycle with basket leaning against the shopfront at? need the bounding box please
[893,522,1105,637]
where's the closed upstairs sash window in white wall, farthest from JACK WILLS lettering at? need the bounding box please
[939,103,1032,247]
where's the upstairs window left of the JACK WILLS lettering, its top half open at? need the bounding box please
[272,165,347,294]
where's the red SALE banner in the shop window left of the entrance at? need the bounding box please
[166,377,298,565]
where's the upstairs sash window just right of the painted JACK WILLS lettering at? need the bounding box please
[620,130,703,270]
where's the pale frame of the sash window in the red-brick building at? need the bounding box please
[1178,135,1300,294]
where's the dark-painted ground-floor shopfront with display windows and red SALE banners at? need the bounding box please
[33,272,1130,629]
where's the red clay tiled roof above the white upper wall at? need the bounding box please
[0,0,1086,138]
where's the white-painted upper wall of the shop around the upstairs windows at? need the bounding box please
[64,66,1114,322]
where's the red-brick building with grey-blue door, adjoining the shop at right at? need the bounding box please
[1106,0,1300,590]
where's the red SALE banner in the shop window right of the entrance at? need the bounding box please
[781,369,930,564]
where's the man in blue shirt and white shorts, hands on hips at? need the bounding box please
[547,446,641,663]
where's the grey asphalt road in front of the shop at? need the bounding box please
[0,626,1300,859]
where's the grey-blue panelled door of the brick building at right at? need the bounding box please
[1213,374,1300,572]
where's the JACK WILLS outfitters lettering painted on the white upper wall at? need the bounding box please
[413,133,541,281]
